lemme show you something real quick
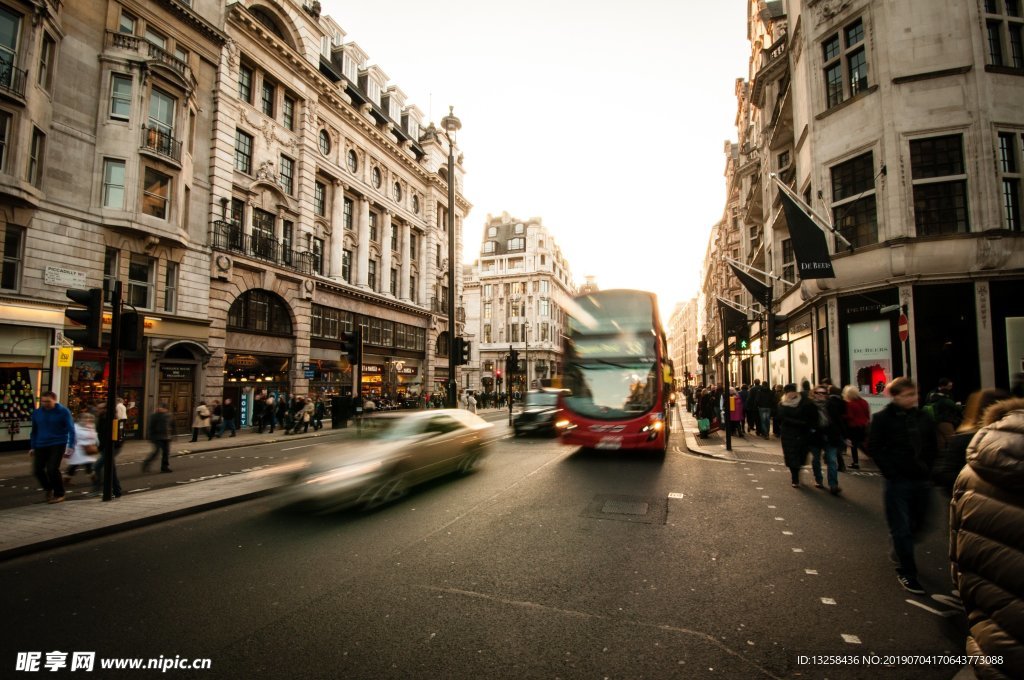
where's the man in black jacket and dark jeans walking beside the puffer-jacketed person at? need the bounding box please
[867,378,938,595]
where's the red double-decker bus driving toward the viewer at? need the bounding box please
[559,290,675,454]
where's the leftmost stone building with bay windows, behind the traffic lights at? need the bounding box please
[0,0,224,438]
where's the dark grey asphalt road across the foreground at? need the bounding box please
[0,428,964,678]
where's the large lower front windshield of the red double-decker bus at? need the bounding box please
[565,359,658,420]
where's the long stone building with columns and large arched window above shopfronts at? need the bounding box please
[203,0,470,414]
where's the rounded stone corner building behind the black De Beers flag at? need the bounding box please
[708,0,1024,406]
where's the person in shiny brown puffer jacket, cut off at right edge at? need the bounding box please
[949,399,1024,680]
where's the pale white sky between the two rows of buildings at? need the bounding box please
[323,0,750,321]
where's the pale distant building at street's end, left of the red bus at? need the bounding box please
[463,212,575,392]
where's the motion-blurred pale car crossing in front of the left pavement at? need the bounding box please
[283,409,494,511]
